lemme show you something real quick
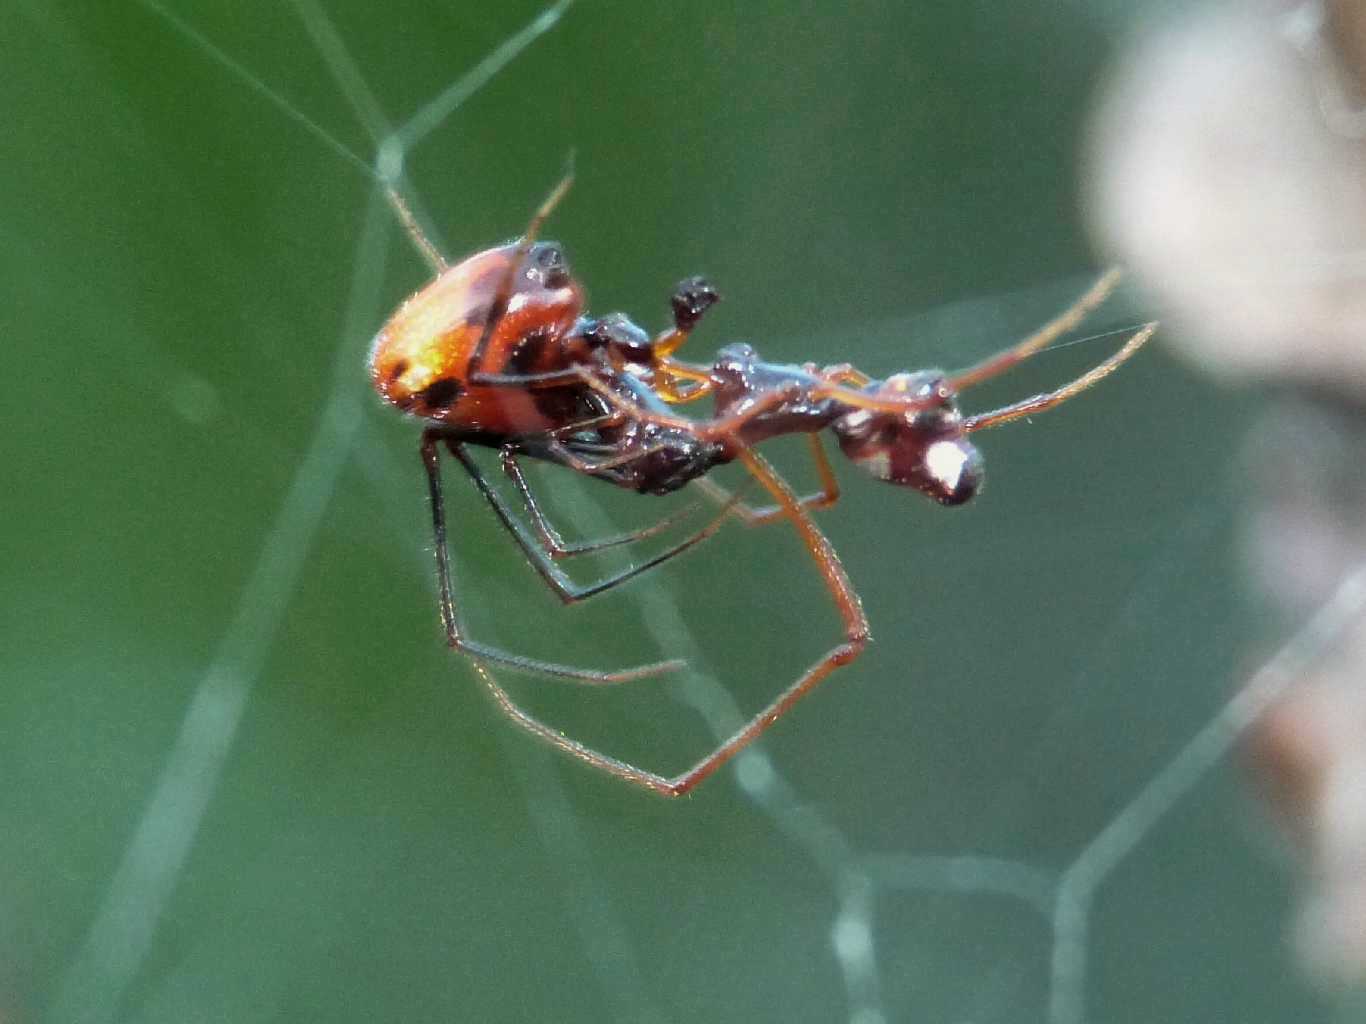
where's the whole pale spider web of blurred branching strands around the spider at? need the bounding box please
[10,0,1349,1024]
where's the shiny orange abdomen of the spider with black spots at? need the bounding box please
[369,242,585,437]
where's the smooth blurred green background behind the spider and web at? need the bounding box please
[0,0,1333,1024]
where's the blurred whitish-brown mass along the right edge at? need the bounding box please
[1089,0,1366,983]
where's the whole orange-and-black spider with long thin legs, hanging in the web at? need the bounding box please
[369,175,1157,796]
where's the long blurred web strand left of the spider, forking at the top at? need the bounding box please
[49,10,570,1024]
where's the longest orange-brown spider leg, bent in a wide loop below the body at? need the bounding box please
[458,448,870,796]
